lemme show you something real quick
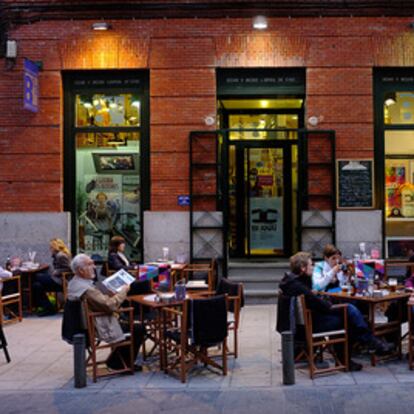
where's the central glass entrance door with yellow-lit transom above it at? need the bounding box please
[219,97,303,258]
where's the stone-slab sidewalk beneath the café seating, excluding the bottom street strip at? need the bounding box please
[0,305,414,396]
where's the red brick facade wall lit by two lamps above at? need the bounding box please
[0,18,414,211]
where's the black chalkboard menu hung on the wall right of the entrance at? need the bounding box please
[336,159,374,209]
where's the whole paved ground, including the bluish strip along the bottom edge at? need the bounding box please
[0,305,414,414]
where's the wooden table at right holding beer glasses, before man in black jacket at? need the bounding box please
[323,291,411,366]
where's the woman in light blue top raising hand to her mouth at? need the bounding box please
[312,244,347,291]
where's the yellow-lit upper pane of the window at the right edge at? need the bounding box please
[384,92,414,125]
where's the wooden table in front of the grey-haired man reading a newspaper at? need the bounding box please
[127,290,215,370]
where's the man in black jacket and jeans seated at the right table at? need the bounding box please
[279,252,391,371]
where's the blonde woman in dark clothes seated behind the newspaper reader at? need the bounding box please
[32,239,71,316]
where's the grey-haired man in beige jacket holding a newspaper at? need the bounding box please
[68,254,145,371]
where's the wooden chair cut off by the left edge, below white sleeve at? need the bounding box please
[0,275,23,324]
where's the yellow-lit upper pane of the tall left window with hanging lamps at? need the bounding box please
[75,94,141,127]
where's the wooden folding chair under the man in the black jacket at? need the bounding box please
[296,295,349,379]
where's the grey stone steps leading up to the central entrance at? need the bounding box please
[228,259,289,304]
